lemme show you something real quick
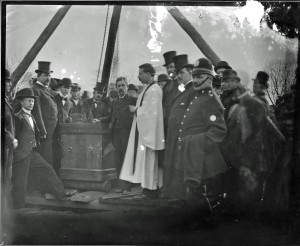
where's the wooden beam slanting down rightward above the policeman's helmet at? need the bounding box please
[166,6,221,66]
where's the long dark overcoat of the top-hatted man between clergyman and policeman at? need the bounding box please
[163,83,197,199]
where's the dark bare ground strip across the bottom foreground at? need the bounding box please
[4,208,300,246]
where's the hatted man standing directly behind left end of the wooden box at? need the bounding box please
[70,83,88,123]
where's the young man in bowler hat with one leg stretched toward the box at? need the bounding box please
[12,88,65,209]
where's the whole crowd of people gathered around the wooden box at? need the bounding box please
[5,51,295,223]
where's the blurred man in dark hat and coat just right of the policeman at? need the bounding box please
[221,69,268,212]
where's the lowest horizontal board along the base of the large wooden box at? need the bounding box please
[60,168,117,181]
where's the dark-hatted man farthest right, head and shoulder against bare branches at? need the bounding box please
[253,71,270,115]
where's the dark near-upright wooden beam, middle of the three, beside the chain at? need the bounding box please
[100,5,122,84]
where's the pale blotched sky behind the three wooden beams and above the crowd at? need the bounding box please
[6,1,297,91]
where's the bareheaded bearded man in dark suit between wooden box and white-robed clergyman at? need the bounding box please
[111,77,136,180]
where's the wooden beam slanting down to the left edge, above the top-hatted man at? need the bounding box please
[11,5,72,90]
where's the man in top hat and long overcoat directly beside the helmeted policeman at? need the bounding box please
[163,55,196,200]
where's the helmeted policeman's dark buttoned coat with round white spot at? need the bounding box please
[179,88,227,186]
